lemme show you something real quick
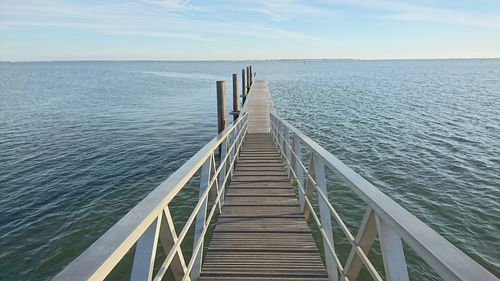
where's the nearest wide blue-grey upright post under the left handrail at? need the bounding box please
[130,216,161,281]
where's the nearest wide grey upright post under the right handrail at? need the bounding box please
[375,216,409,281]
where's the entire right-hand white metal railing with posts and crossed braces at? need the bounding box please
[271,112,498,281]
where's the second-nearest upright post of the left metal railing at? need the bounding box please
[190,156,213,280]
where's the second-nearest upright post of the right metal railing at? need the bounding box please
[313,154,338,281]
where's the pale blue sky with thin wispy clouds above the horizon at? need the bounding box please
[0,0,500,61]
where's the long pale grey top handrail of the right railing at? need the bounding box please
[271,113,498,280]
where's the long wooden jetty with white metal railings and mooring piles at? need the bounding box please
[54,66,499,281]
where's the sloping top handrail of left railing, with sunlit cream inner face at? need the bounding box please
[54,114,246,280]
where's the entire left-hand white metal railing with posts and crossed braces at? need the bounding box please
[54,114,248,280]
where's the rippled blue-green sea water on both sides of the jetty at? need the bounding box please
[0,60,500,280]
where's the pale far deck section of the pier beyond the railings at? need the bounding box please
[243,80,271,134]
